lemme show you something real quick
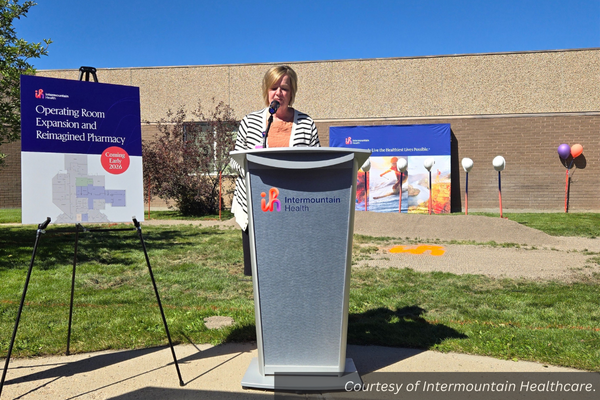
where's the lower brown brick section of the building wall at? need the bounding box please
[0,114,600,212]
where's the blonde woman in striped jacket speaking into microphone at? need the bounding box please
[231,65,321,276]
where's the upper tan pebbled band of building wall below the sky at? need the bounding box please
[38,49,600,121]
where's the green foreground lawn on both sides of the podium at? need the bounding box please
[0,225,600,371]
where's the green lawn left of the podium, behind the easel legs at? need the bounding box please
[0,222,254,356]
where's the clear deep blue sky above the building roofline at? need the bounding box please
[15,0,600,69]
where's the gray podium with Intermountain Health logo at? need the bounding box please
[231,147,371,390]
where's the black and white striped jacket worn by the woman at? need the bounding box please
[231,108,321,230]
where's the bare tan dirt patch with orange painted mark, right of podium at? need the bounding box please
[354,212,600,282]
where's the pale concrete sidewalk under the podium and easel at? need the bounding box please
[1,343,576,400]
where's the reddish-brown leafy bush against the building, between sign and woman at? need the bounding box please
[142,102,239,216]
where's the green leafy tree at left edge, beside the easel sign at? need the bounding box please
[0,0,52,165]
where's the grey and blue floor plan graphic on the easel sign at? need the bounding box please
[52,154,126,223]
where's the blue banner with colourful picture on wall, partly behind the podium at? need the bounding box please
[329,124,451,214]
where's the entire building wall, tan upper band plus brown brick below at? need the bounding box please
[0,49,600,211]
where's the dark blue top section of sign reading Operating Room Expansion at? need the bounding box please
[21,75,142,156]
